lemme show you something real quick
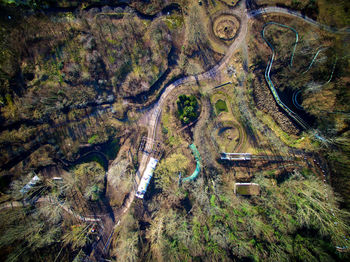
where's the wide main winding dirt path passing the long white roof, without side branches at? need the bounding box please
[97,1,350,258]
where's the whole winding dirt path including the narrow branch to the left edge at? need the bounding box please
[0,3,350,261]
